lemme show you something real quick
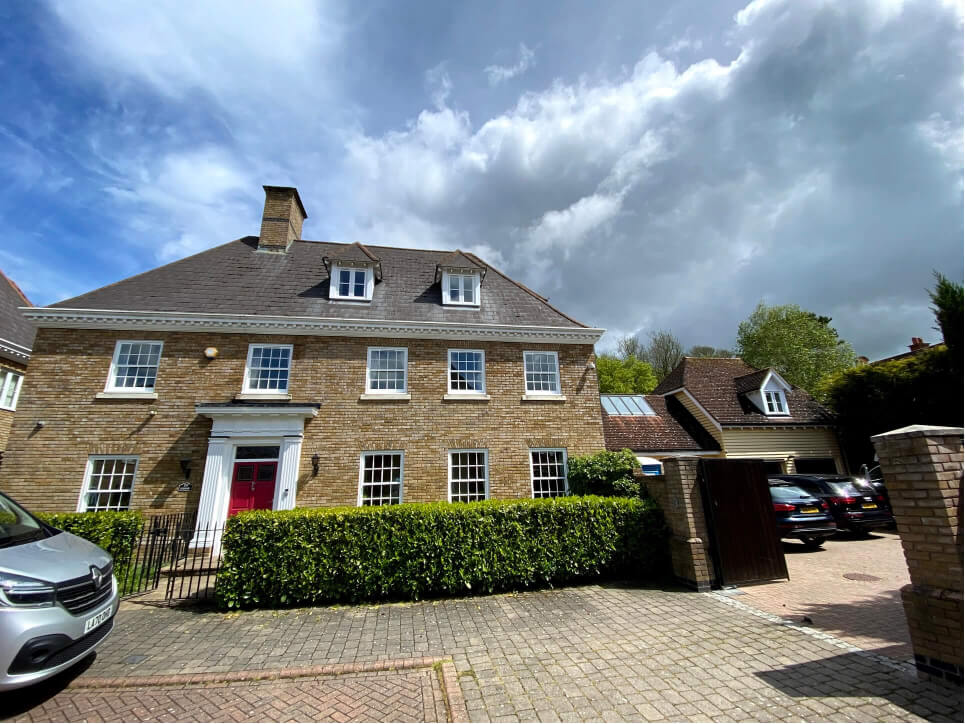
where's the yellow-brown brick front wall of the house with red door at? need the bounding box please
[0,329,603,511]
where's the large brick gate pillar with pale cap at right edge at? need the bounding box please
[871,425,963,686]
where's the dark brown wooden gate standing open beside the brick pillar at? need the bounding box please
[698,460,788,586]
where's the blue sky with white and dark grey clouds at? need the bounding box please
[0,0,963,358]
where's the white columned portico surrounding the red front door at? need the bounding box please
[191,402,318,547]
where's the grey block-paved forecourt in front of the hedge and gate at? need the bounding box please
[3,585,962,721]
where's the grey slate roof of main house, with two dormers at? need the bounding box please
[51,237,587,328]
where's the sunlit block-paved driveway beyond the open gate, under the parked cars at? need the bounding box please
[739,531,912,660]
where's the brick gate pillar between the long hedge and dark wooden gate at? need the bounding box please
[645,458,714,591]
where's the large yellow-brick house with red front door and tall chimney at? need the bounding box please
[0,186,603,544]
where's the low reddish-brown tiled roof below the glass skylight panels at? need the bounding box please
[603,395,720,452]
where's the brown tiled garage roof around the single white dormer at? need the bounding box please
[654,357,832,427]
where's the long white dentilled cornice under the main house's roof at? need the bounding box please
[21,307,606,344]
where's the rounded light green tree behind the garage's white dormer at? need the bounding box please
[737,302,856,394]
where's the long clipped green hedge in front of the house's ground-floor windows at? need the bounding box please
[217,497,668,608]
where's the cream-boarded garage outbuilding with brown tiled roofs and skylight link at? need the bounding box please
[602,357,847,473]
